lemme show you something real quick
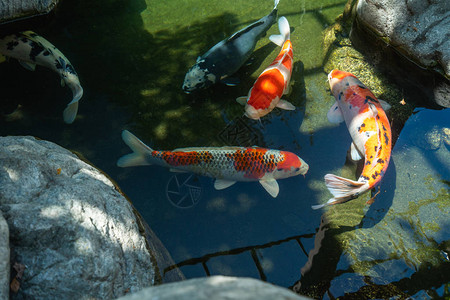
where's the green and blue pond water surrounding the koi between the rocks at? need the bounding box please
[0,0,450,299]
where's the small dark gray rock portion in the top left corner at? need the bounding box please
[0,0,59,23]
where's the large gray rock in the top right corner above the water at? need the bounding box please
[352,0,450,107]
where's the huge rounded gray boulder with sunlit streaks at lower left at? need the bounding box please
[0,137,155,299]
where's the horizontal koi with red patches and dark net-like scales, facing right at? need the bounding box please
[117,130,309,198]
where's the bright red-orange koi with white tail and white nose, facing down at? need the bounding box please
[236,17,295,120]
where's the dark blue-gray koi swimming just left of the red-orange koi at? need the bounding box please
[182,0,280,93]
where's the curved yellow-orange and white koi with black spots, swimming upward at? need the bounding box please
[312,70,392,209]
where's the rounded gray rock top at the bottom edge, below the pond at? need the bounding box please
[116,276,309,300]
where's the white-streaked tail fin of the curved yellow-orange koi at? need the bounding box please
[311,174,369,209]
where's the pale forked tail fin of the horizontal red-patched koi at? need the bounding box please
[117,130,153,167]
